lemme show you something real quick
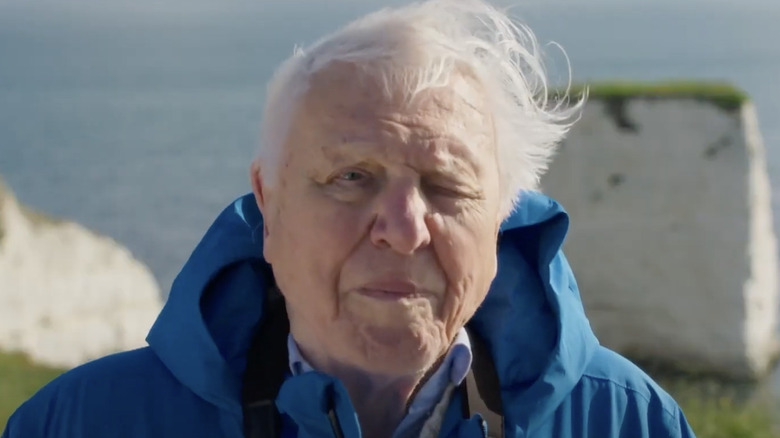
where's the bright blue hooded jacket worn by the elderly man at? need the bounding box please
[2,193,693,438]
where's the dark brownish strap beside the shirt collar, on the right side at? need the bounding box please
[461,327,504,438]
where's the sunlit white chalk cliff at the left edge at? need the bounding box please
[0,181,162,367]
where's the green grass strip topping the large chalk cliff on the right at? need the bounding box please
[553,80,748,111]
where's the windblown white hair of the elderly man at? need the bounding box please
[258,0,584,216]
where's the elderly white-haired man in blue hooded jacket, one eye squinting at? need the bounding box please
[3,0,693,438]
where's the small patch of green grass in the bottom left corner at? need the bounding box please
[0,353,63,431]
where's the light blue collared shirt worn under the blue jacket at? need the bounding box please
[287,328,472,438]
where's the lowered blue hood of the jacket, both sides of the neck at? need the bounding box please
[147,192,598,430]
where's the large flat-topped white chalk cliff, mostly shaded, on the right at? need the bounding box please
[542,97,780,377]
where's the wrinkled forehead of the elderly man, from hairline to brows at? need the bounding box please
[296,62,495,153]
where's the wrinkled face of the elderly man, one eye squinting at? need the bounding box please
[253,64,501,375]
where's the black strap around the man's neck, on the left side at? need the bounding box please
[241,288,290,438]
